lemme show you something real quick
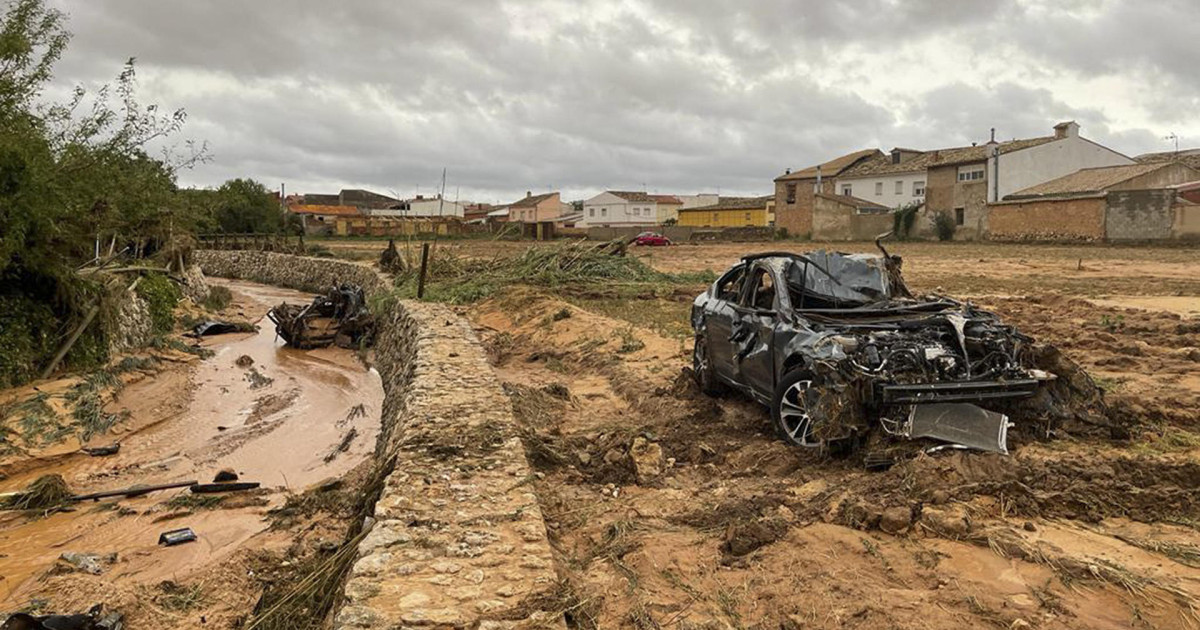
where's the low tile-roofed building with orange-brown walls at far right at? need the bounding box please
[988,162,1200,241]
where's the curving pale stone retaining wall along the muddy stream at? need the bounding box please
[196,251,562,629]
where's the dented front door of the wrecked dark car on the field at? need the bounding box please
[731,263,782,401]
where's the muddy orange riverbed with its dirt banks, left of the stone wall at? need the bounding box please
[0,281,383,628]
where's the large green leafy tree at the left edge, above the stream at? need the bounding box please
[0,0,205,384]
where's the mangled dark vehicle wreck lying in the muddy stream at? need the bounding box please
[266,284,374,348]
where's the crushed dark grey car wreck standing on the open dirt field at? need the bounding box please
[691,238,1108,452]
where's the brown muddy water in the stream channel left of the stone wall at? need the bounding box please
[0,282,383,610]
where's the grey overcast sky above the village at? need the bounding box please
[48,0,1200,202]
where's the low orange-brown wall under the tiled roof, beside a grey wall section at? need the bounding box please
[988,197,1105,241]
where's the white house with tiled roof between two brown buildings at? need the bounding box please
[835,148,932,209]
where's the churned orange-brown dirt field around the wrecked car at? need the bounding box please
[453,244,1200,630]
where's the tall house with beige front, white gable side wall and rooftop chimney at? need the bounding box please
[923,121,1134,239]
